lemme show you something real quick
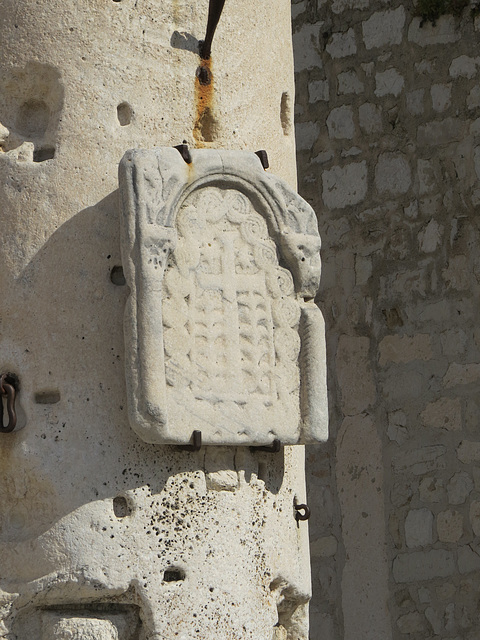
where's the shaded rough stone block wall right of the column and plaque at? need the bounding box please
[292,0,480,640]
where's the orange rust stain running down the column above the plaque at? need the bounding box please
[193,58,217,148]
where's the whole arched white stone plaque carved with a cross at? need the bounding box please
[120,149,327,446]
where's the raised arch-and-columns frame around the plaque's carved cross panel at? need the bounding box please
[119,148,328,445]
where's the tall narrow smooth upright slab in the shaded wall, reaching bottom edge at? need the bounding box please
[336,415,392,640]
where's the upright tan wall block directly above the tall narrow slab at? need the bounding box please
[336,335,376,415]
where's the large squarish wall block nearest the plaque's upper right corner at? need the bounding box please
[322,161,367,209]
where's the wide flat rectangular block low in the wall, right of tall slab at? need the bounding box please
[393,549,455,582]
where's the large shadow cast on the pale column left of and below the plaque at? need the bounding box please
[0,191,284,543]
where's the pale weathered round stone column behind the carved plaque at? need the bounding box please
[0,0,310,640]
